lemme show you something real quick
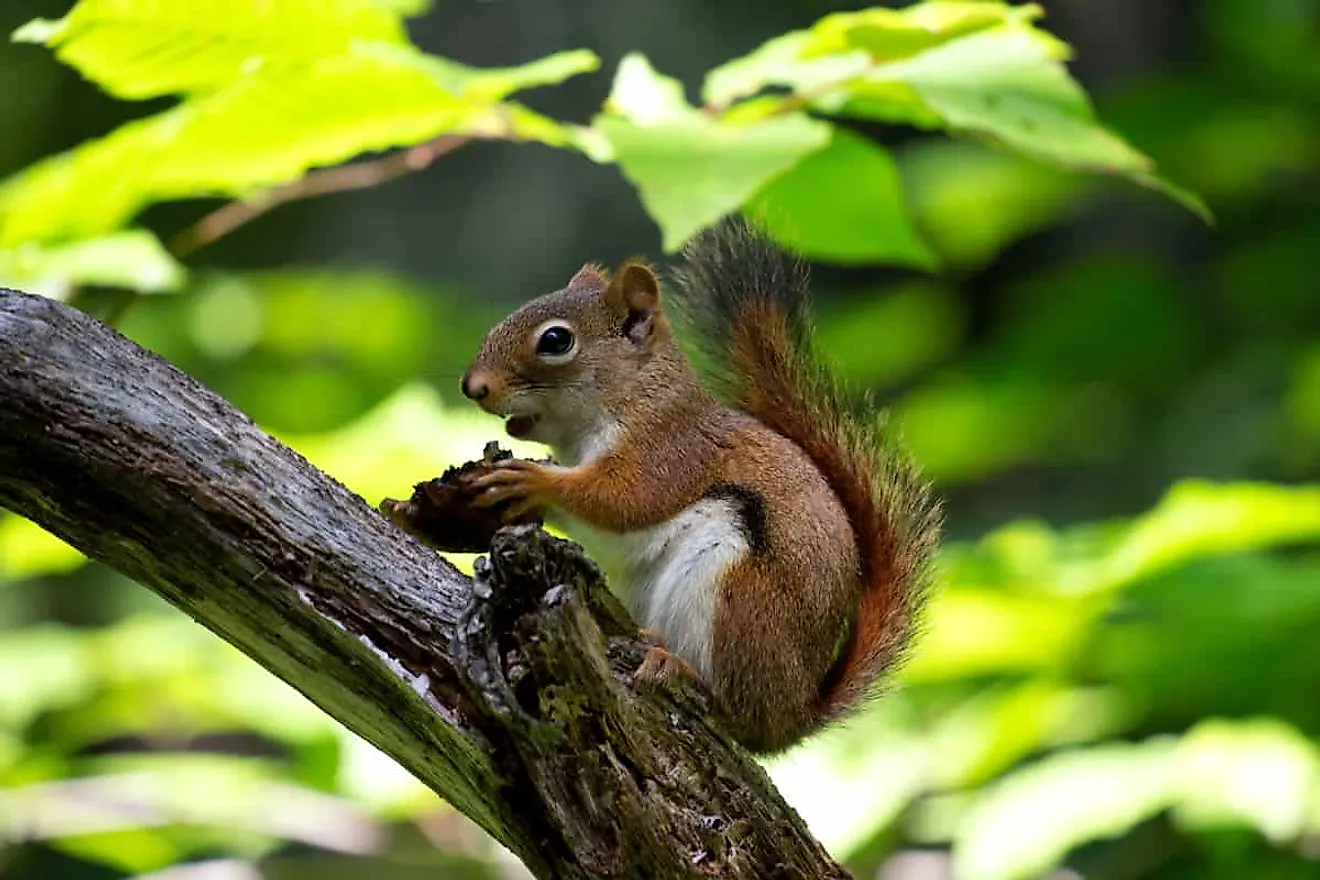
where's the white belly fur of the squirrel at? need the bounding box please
[551,500,748,682]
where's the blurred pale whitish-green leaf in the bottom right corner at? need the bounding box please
[953,719,1320,880]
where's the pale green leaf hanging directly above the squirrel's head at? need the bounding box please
[595,55,830,251]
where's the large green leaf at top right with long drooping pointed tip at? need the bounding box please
[704,1,1209,219]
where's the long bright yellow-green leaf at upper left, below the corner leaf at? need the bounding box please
[0,44,597,247]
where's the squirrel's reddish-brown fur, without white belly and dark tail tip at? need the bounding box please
[465,236,933,751]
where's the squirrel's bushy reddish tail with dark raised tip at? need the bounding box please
[675,220,941,720]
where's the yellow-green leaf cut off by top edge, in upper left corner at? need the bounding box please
[13,0,408,99]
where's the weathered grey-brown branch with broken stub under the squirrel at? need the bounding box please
[0,292,846,877]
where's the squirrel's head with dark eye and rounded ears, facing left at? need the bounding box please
[462,261,681,453]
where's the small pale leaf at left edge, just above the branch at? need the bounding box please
[0,230,185,299]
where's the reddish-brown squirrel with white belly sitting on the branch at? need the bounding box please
[462,219,941,753]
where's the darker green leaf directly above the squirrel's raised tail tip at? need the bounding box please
[746,129,936,269]
